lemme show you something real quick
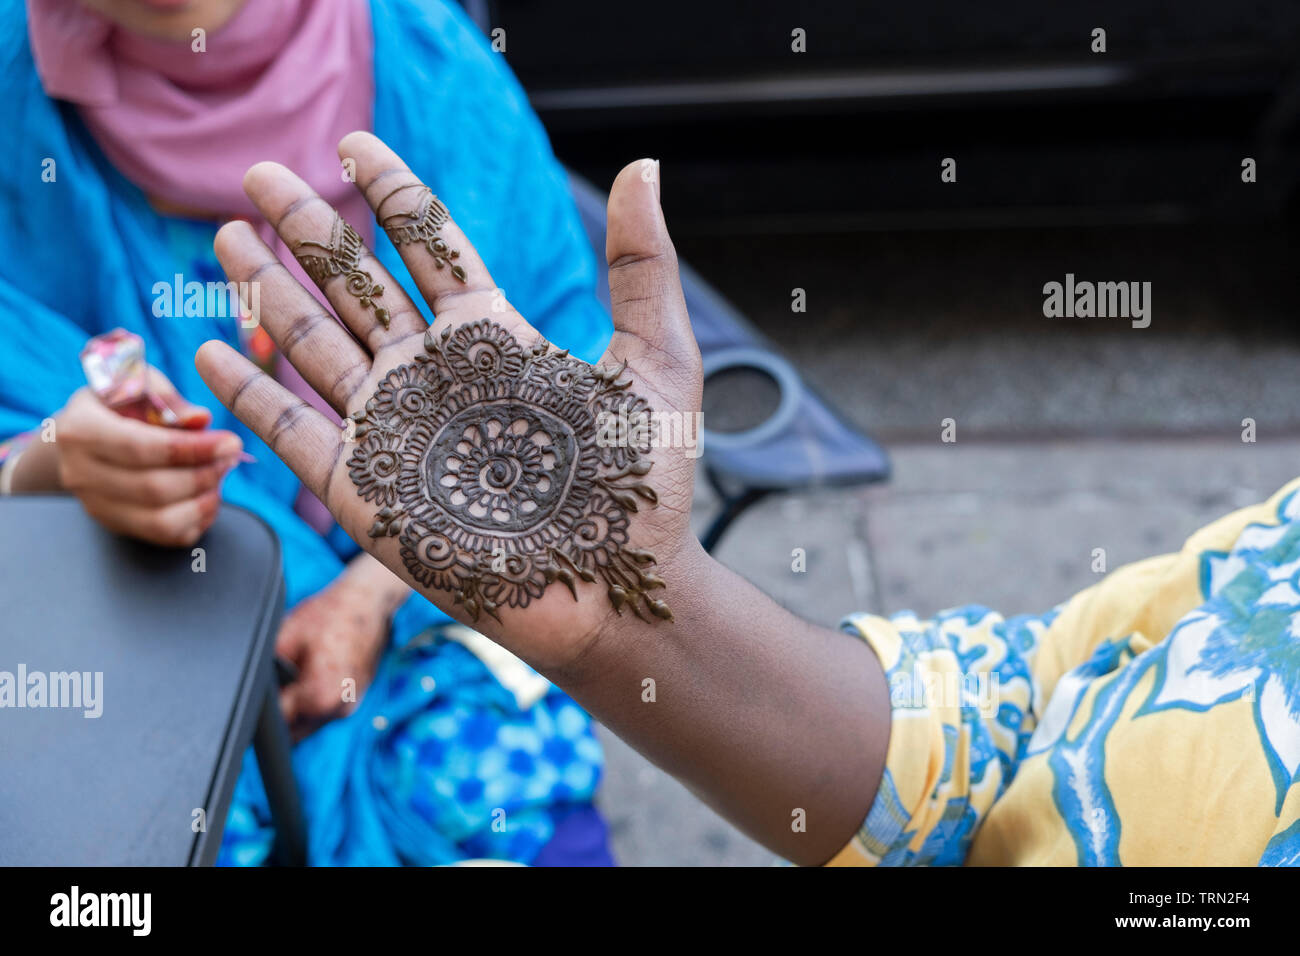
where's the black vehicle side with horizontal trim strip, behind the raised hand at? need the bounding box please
[468,0,1300,234]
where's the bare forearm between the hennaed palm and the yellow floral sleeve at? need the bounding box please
[550,541,889,864]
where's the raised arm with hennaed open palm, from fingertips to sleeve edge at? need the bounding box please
[196,133,889,862]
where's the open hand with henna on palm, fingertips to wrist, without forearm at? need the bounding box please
[196,133,701,670]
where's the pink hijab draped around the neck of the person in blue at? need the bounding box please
[27,0,374,238]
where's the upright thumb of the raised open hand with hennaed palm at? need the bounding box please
[605,159,696,362]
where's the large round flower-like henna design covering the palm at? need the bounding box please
[347,319,672,620]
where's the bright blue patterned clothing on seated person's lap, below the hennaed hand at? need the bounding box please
[217,632,601,866]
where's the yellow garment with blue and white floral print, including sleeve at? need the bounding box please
[832,480,1300,866]
